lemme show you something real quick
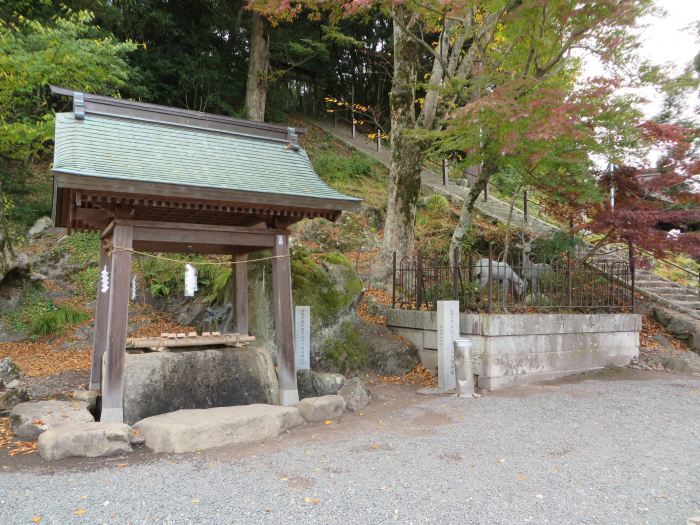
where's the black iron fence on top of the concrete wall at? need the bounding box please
[392,248,634,313]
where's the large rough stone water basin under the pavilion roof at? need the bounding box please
[123,348,279,424]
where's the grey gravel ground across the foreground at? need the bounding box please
[0,370,700,525]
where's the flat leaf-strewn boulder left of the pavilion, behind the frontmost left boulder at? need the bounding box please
[10,400,95,439]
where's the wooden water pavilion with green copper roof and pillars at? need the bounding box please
[52,87,359,422]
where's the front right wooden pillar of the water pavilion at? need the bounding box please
[272,234,299,406]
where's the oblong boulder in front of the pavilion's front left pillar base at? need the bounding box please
[38,422,131,461]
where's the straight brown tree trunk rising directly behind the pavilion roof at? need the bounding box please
[245,13,270,122]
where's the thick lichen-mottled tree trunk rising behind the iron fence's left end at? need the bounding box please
[380,5,423,278]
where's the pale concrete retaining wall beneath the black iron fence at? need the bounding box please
[387,310,642,390]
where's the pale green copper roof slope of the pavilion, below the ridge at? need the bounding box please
[53,113,360,207]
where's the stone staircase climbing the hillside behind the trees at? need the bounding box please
[304,117,700,320]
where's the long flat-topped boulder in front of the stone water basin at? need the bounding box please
[134,404,304,453]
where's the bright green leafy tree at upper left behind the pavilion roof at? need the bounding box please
[0,11,135,163]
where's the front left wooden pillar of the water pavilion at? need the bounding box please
[100,224,134,423]
